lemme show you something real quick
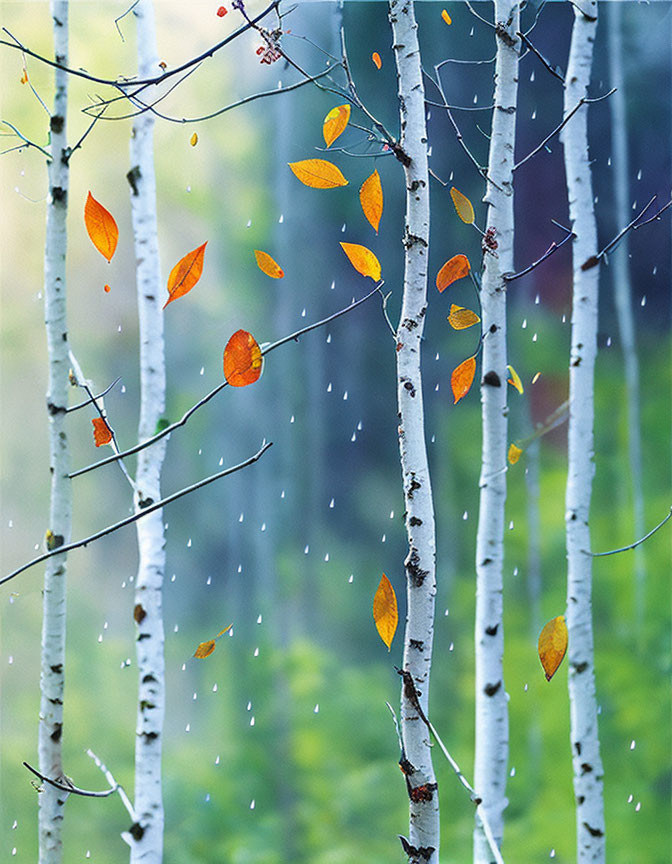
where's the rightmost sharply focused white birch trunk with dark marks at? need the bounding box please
[562,0,605,864]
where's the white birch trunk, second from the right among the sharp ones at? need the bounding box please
[474,6,520,864]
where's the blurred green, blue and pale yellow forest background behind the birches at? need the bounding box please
[0,0,672,864]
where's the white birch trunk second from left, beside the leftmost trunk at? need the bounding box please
[128,0,166,864]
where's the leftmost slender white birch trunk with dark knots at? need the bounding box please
[38,0,72,864]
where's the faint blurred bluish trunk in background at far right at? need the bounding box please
[607,3,646,642]
